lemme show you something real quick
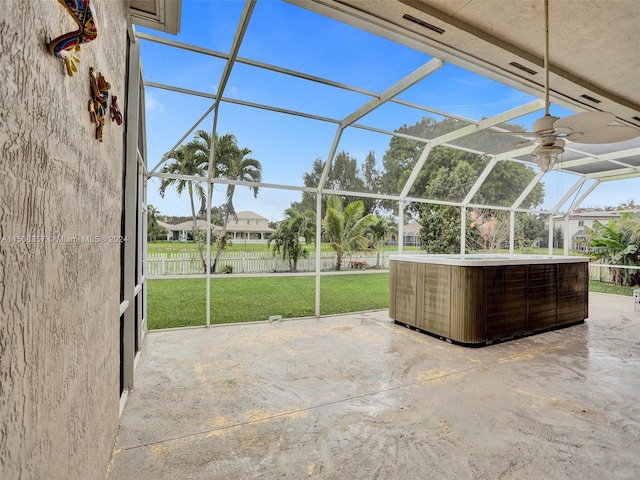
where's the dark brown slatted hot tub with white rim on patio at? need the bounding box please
[389,255,589,346]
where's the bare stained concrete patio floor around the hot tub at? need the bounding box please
[106,293,640,480]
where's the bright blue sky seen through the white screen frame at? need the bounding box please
[138,0,640,221]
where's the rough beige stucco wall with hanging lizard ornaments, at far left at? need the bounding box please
[0,0,127,480]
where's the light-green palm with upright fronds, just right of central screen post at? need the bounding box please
[322,195,376,270]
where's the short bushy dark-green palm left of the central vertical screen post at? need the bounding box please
[267,208,315,273]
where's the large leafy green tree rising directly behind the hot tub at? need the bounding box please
[381,118,544,253]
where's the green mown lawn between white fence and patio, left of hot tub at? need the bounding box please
[148,273,389,329]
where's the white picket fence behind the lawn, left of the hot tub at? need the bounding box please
[146,252,389,276]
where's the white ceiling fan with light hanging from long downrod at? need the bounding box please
[496,0,640,172]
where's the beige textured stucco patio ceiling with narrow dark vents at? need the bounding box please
[312,0,640,127]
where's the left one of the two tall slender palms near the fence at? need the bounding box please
[160,145,207,273]
